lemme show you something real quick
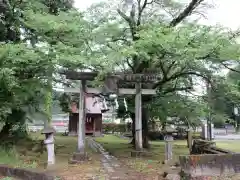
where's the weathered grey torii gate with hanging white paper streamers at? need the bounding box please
[64,71,160,160]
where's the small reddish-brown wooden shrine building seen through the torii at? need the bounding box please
[68,94,104,136]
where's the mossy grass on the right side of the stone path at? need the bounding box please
[96,135,240,173]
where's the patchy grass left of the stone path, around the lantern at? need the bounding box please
[0,133,105,179]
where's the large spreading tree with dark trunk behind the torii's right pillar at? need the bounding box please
[80,0,239,147]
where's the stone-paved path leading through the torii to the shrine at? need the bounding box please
[87,138,155,180]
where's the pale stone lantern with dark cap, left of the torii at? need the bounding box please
[42,127,56,167]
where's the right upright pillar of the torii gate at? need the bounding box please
[135,83,143,151]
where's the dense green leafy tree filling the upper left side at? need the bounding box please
[0,0,84,137]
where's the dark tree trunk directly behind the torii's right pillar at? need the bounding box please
[142,107,150,148]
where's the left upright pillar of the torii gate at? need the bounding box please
[78,81,86,153]
